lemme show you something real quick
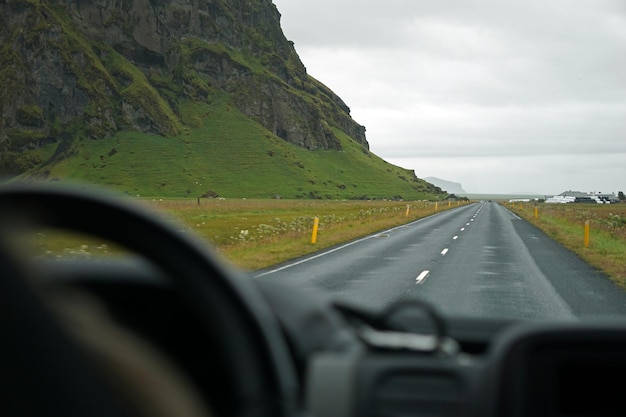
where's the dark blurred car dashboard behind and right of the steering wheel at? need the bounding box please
[34,259,626,417]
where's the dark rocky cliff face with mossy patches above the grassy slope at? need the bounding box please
[0,0,368,171]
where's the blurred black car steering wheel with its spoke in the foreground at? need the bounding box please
[0,185,298,417]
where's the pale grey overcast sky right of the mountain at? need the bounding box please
[273,0,626,194]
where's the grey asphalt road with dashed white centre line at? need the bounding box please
[254,202,626,319]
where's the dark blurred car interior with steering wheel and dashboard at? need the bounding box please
[0,185,626,417]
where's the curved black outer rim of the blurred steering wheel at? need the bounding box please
[0,184,298,417]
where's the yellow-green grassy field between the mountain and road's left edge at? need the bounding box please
[35,198,464,270]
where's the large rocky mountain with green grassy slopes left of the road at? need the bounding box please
[0,0,440,198]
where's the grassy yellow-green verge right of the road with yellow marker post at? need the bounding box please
[507,203,626,289]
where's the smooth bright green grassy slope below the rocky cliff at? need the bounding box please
[21,95,439,200]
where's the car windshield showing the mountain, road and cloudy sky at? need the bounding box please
[0,0,626,320]
